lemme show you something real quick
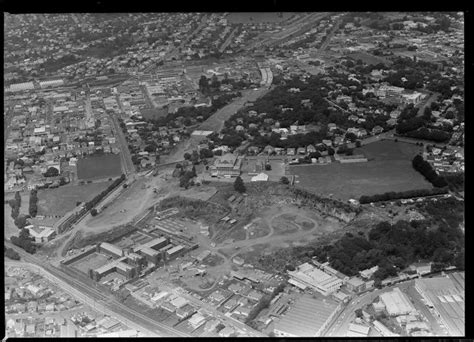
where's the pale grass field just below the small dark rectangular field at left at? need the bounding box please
[37,181,112,216]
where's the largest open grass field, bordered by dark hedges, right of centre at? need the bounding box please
[290,141,431,200]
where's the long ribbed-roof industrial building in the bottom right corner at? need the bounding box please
[415,273,466,336]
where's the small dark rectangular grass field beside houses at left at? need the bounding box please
[77,154,122,180]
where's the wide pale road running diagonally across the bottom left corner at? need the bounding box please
[4,240,189,337]
